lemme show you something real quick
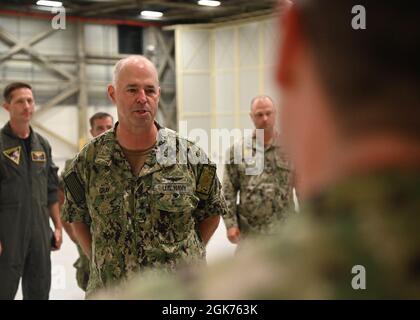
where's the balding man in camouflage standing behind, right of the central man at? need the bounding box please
[223,96,294,244]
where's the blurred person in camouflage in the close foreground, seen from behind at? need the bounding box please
[93,0,420,299]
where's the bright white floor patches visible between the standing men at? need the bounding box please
[16,221,235,300]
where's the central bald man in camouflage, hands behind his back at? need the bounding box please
[63,56,227,294]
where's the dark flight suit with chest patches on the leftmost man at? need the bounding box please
[0,123,58,299]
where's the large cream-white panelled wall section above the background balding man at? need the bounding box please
[176,15,278,139]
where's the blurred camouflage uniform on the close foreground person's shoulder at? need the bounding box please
[99,171,420,299]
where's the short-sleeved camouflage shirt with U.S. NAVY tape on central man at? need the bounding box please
[63,123,227,293]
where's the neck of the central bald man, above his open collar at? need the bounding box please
[117,123,158,150]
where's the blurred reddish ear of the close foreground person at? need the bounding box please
[276,5,302,87]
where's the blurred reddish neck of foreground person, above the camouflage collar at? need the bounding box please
[301,135,420,197]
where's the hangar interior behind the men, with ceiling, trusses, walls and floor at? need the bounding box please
[0,0,281,299]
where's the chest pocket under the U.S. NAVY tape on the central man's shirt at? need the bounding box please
[152,175,199,243]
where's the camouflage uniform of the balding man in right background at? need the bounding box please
[223,135,294,236]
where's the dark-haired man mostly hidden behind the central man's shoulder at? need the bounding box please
[58,112,114,291]
